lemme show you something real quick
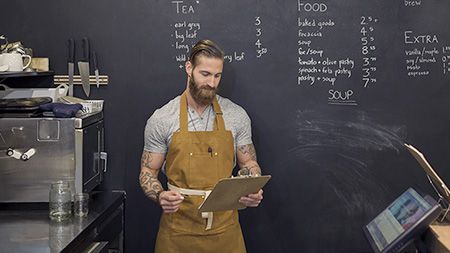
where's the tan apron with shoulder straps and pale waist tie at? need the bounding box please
[155,92,246,253]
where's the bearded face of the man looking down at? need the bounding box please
[186,56,223,106]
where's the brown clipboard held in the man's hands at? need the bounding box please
[198,175,272,212]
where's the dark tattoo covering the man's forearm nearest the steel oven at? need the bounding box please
[139,153,163,202]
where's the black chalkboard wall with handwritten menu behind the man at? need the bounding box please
[0,0,450,253]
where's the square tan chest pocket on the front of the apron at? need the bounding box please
[186,152,220,189]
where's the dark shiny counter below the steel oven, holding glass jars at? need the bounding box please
[0,192,125,253]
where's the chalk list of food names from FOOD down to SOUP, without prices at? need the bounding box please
[297,0,357,105]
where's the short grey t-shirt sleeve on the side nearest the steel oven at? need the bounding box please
[144,112,167,153]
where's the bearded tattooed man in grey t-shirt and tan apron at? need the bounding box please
[139,40,263,253]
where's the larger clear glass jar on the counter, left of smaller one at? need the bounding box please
[48,181,72,221]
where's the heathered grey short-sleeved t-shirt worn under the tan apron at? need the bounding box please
[144,95,252,154]
